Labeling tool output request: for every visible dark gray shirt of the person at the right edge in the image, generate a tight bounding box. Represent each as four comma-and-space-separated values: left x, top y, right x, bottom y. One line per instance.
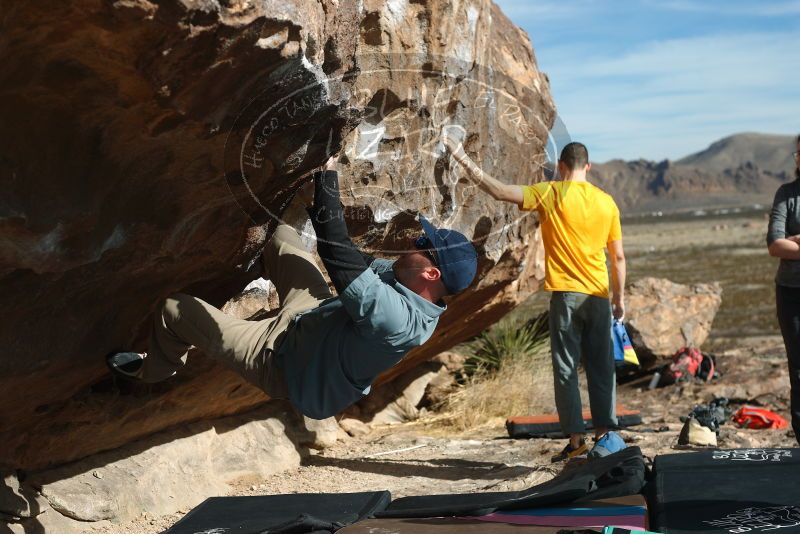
767, 179, 800, 287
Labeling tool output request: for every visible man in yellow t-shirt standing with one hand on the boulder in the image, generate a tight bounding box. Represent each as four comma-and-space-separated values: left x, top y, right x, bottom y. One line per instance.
445, 137, 625, 461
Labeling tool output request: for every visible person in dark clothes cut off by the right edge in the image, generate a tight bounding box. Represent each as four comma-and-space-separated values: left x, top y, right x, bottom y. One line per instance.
767, 135, 800, 443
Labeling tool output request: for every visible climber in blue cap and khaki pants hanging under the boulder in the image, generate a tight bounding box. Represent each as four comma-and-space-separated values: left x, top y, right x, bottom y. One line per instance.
106, 158, 477, 419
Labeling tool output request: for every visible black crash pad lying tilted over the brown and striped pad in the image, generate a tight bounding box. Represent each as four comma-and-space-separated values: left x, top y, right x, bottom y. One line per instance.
375, 447, 645, 518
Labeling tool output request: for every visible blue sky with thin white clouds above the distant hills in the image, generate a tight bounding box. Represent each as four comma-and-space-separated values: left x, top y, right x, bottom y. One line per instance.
495, 0, 800, 161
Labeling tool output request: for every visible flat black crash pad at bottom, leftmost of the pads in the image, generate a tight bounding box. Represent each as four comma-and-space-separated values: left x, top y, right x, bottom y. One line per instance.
163, 491, 391, 534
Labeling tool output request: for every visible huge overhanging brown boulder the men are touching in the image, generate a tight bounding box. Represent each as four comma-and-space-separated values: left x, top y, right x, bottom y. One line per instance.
0, 0, 554, 469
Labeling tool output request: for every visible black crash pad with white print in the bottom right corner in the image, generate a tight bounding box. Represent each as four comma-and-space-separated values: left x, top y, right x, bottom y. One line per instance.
646, 448, 800, 534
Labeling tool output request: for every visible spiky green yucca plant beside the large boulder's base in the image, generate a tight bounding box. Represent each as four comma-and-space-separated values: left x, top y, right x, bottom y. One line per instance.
464, 312, 549, 377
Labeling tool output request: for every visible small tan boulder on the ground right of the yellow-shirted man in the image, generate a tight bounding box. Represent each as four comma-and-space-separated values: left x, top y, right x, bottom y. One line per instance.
625, 278, 722, 357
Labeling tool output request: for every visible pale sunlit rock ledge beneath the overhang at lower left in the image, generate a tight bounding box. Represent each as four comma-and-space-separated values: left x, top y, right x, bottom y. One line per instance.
0, 402, 326, 532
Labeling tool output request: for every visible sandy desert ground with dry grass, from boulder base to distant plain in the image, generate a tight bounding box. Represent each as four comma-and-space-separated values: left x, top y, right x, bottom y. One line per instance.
97, 213, 796, 534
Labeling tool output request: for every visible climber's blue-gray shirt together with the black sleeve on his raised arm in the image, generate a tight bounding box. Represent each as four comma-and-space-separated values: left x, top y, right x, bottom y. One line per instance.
276, 171, 445, 419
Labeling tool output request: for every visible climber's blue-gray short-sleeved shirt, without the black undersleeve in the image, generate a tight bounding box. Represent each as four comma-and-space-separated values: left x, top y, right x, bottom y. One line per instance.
277, 260, 445, 419
